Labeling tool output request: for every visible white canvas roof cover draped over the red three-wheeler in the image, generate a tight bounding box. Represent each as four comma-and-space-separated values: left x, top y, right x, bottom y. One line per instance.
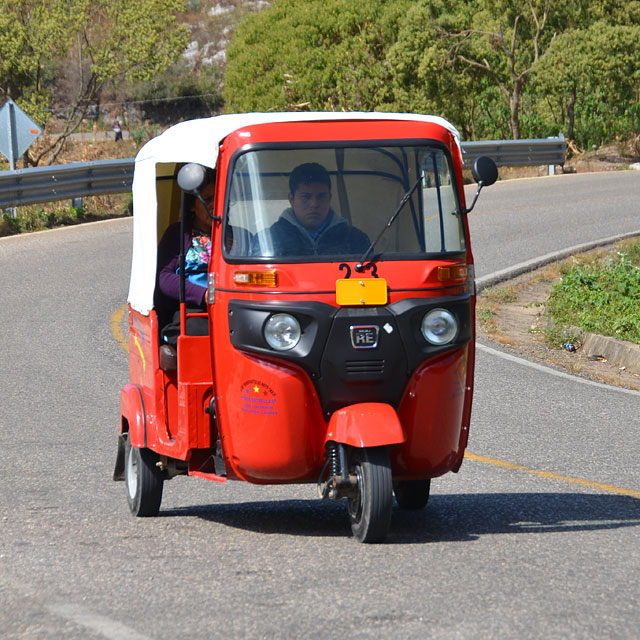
128, 112, 460, 315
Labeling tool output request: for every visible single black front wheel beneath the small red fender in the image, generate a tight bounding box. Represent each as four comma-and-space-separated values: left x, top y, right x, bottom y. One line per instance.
348, 447, 393, 542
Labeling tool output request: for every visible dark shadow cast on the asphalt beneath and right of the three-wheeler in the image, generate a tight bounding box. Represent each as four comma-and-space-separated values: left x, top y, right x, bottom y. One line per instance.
160, 493, 640, 544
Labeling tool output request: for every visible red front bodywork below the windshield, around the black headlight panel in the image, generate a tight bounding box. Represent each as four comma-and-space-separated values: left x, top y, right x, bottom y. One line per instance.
212, 262, 473, 483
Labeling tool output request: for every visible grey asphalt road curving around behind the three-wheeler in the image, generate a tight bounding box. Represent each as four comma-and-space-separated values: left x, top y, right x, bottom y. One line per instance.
0, 172, 640, 640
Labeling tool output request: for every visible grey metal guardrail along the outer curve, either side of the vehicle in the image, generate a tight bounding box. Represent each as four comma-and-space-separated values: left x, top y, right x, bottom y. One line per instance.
0, 135, 566, 208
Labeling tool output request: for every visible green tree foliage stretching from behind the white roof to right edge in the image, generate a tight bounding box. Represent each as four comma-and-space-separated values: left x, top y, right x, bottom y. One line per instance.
224, 0, 640, 145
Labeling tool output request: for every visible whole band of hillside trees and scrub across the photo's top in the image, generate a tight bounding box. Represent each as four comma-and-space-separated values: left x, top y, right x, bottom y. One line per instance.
0, 0, 640, 168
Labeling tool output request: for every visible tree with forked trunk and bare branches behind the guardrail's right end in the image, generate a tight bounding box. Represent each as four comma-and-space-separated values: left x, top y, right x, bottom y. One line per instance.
388, 0, 583, 139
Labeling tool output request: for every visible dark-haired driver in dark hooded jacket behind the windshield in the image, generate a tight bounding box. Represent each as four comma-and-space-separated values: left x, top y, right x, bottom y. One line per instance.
254, 162, 370, 256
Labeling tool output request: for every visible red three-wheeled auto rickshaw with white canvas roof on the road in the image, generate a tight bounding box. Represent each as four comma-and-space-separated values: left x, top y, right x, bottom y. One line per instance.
114, 113, 497, 542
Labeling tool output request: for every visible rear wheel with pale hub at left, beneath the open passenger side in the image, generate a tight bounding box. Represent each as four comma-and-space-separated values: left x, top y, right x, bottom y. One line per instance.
124, 440, 164, 517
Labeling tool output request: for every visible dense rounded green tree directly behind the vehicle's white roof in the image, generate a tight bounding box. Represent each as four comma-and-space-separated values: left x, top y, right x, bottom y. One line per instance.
223, 0, 408, 112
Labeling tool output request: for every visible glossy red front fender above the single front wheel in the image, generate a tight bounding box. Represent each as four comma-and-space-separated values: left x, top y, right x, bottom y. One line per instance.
325, 402, 405, 448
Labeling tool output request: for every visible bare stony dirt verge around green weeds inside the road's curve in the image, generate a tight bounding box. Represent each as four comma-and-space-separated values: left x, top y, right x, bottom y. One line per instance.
477, 246, 640, 391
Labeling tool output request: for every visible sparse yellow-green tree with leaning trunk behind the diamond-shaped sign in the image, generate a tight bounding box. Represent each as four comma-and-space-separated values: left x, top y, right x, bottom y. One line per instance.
0, 0, 188, 165
